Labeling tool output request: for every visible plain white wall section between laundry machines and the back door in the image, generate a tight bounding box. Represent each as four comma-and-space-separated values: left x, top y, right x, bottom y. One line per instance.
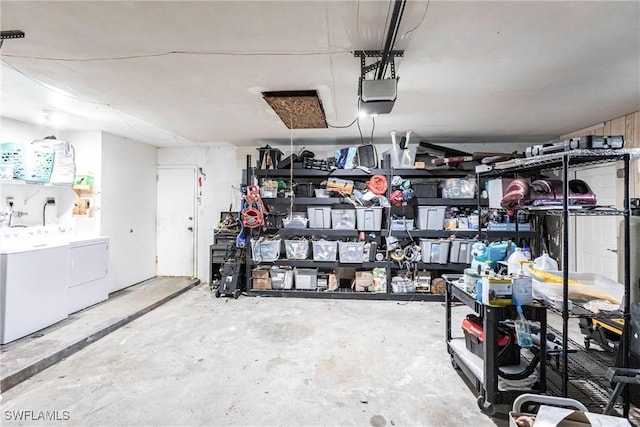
101, 133, 157, 292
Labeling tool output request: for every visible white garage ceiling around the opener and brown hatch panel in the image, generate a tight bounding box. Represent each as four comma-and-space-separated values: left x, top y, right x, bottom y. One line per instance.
0, 0, 640, 146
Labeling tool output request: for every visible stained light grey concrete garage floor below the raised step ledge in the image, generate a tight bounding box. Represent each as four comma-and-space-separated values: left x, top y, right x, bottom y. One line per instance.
0, 285, 506, 427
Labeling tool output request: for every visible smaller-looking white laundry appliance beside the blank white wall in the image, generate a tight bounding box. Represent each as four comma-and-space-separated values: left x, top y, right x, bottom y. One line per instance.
68, 237, 109, 313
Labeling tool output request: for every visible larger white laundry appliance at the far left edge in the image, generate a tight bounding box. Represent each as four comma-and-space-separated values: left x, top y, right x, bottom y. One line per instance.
0, 239, 69, 344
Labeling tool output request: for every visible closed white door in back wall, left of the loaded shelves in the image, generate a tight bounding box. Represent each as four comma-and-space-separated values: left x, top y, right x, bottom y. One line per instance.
156, 167, 196, 277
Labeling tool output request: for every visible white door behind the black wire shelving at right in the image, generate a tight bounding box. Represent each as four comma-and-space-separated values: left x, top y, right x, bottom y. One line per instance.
574, 164, 619, 280
